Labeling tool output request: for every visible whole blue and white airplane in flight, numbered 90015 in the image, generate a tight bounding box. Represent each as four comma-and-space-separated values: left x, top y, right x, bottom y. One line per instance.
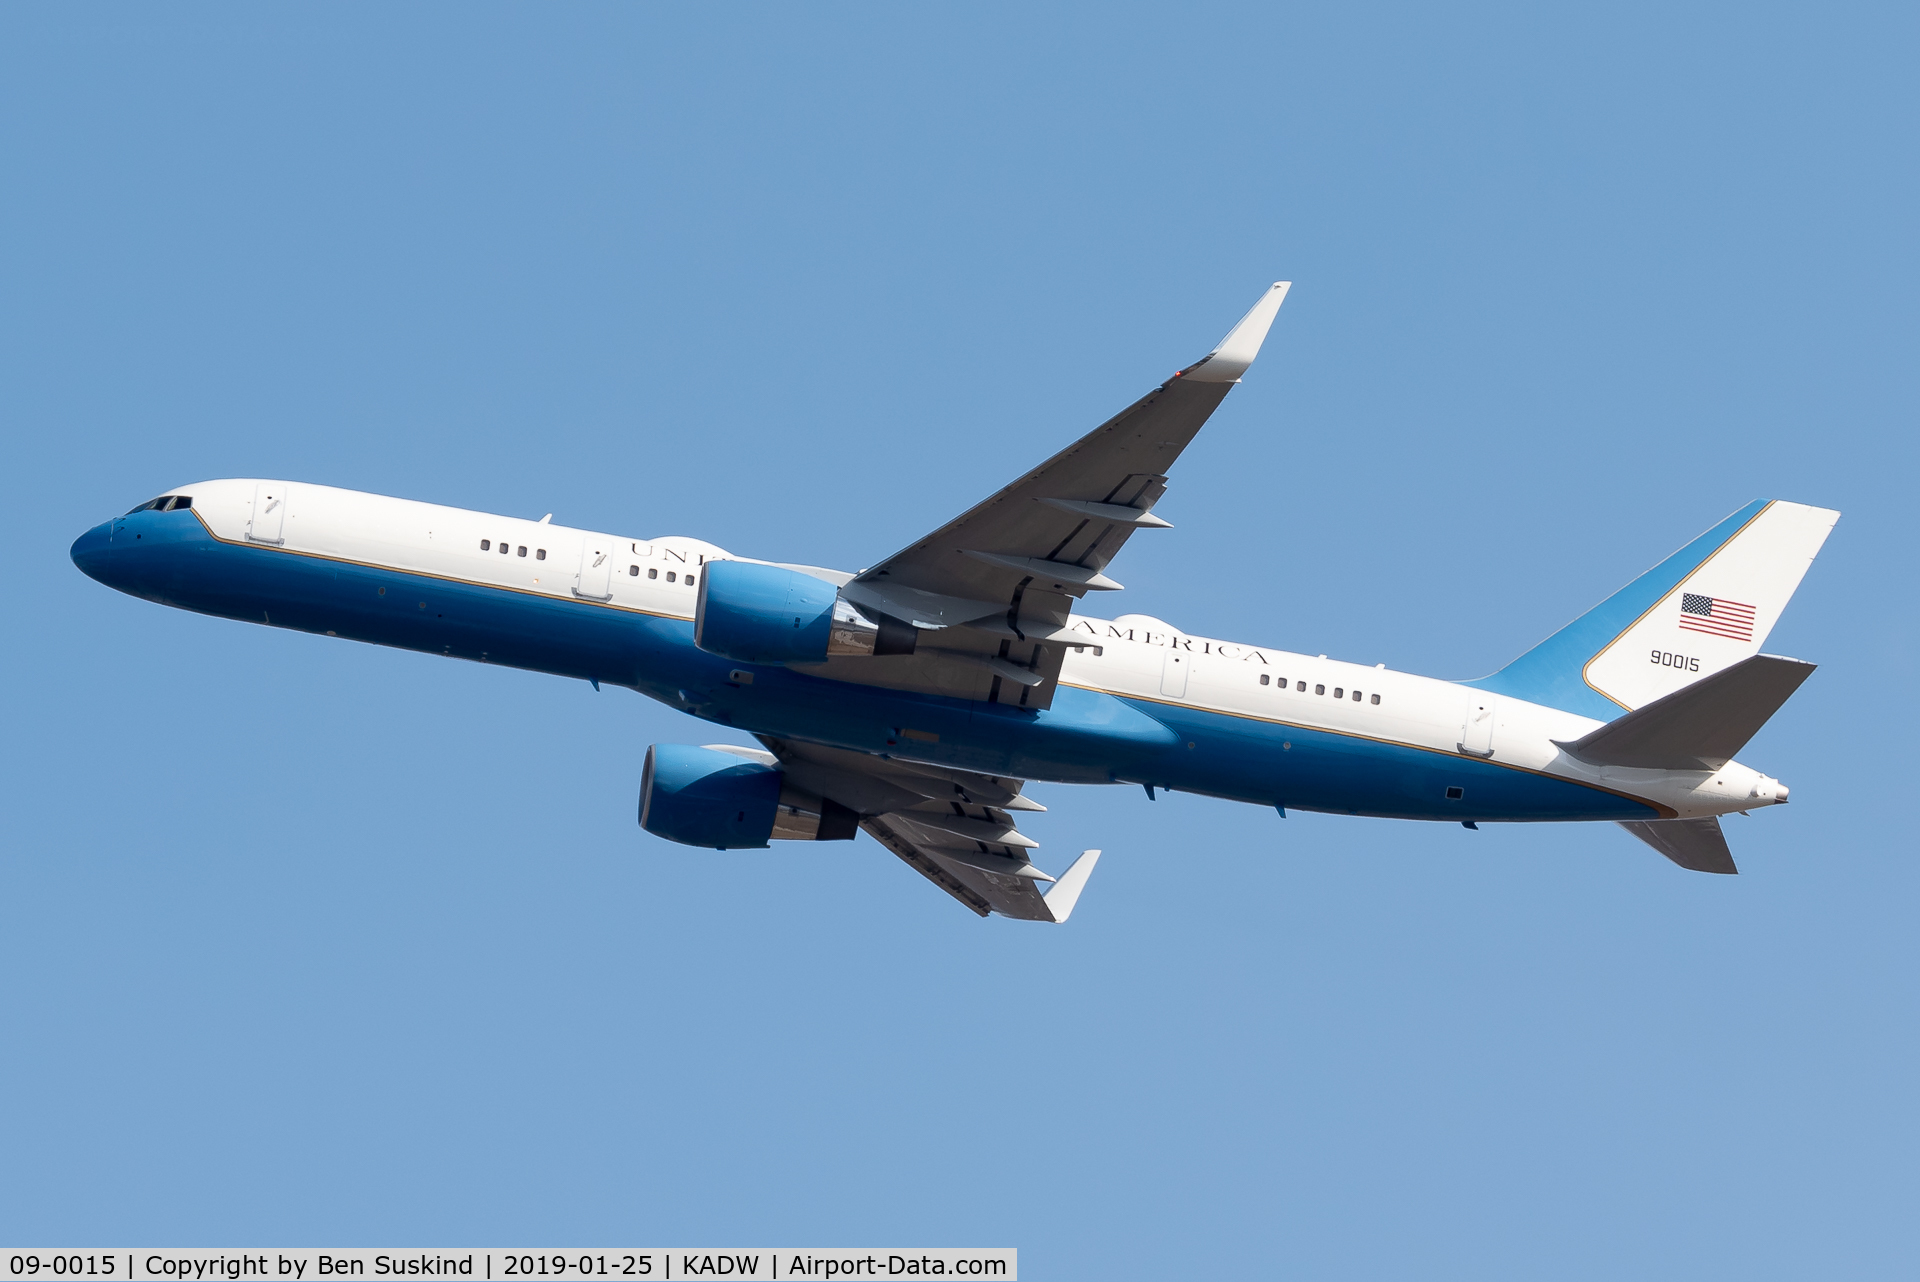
73, 282, 1839, 921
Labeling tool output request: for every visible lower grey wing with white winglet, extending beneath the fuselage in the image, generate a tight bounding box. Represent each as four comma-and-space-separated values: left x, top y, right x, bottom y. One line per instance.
760, 735, 1100, 921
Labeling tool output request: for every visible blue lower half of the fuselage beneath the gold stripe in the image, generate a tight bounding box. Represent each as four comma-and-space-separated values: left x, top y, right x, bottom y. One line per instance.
109, 512, 1655, 819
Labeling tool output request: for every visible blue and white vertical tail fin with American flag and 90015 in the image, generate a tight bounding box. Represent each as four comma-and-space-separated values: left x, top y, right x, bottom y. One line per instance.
1465, 499, 1839, 722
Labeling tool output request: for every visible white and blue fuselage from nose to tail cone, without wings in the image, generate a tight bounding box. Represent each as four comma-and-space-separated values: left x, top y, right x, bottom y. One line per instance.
73, 480, 1797, 821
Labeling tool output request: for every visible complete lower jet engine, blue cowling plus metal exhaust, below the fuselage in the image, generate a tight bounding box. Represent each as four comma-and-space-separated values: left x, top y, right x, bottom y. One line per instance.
639, 740, 860, 850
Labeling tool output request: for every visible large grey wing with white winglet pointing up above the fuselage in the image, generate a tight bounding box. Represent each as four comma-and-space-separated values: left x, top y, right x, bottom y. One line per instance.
798, 280, 1288, 708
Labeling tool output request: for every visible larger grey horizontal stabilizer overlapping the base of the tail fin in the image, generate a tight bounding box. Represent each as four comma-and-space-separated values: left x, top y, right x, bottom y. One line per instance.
1553, 654, 1814, 767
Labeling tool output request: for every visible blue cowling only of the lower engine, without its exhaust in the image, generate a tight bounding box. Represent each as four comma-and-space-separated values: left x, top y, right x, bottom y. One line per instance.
639, 740, 781, 850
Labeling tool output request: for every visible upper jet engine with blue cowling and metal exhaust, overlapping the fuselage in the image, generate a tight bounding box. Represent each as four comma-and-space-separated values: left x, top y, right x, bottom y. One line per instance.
693, 560, 916, 664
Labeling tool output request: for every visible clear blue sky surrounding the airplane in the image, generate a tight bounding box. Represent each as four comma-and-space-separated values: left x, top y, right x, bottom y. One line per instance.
0, 4, 1920, 1278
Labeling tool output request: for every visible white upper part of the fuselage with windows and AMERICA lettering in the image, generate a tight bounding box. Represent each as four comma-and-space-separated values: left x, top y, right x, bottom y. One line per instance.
168, 480, 1784, 818
